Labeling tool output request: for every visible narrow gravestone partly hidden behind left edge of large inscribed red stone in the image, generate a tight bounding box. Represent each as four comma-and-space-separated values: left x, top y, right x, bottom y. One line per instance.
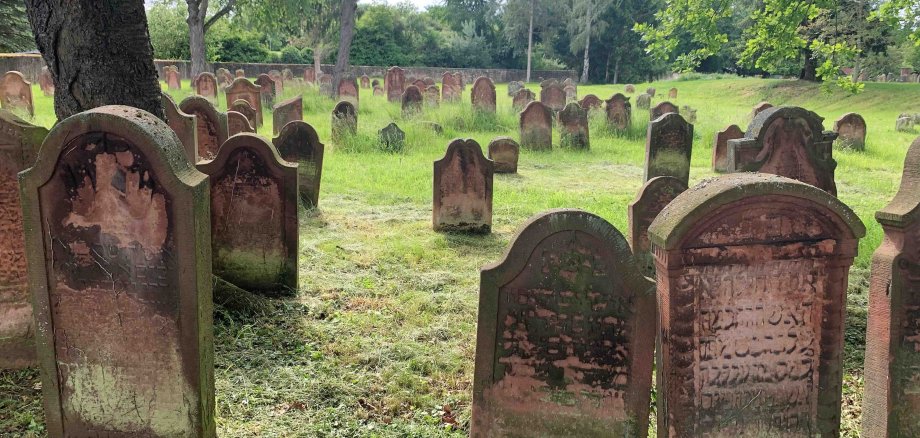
627, 176, 687, 278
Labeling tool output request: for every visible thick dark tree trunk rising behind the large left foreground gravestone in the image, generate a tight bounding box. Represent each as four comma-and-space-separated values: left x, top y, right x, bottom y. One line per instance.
25, 0, 165, 119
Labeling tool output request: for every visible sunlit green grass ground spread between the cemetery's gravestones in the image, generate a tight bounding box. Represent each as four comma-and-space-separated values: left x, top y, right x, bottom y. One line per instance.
0, 73, 920, 437
